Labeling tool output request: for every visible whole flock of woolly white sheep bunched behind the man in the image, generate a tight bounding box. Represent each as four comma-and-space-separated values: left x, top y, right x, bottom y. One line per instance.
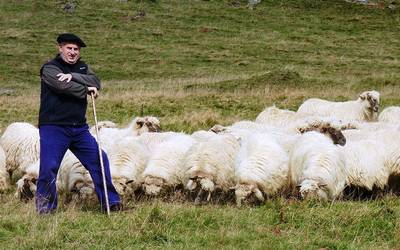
0, 91, 400, 206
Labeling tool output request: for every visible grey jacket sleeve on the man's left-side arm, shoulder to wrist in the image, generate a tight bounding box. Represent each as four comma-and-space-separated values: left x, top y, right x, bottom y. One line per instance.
41, 65, 88, 99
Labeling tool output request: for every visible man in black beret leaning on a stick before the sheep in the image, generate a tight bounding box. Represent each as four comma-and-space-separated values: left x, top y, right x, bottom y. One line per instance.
36, 33, 121, 214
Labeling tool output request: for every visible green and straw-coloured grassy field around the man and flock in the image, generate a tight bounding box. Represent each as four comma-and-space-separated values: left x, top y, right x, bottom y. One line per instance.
0, 0, 400, 249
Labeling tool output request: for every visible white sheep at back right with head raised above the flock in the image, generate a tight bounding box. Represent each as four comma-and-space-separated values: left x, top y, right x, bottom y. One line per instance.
297, 90, 380, 122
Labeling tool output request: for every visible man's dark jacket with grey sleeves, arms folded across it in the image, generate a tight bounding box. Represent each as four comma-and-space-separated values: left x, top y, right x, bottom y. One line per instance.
39, 55, 100, 126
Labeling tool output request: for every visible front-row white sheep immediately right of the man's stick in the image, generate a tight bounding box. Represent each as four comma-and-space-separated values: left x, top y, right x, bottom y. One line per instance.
108, 136, 150, 199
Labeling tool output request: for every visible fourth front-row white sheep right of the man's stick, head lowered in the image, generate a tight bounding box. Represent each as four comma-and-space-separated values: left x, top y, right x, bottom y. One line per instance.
235, 133, 289, 206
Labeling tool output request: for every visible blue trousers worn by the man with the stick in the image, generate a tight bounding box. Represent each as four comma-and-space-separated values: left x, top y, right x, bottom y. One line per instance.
36, 125, 120, 214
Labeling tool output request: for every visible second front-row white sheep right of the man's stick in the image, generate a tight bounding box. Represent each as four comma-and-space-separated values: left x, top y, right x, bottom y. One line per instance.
142, 134, 195, 196
